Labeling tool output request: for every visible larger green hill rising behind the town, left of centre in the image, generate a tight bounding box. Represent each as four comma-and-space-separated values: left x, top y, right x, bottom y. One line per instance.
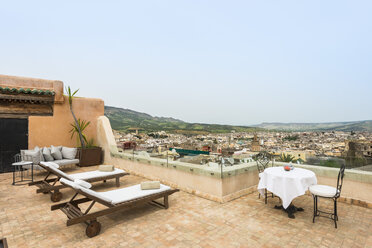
105, 106, 260, 134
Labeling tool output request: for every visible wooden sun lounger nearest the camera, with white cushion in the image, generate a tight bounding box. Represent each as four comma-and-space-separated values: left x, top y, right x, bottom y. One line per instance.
51, 179, 179, 238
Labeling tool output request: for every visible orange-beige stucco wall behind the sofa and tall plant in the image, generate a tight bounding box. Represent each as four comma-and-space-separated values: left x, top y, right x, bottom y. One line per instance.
28, 96, 104, 149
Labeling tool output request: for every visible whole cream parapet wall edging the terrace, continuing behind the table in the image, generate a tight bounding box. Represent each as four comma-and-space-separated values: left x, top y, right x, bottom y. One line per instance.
97, 116, 372, 208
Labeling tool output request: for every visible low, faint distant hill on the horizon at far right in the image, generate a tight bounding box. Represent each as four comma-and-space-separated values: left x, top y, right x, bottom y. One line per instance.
255, 120, 372, 132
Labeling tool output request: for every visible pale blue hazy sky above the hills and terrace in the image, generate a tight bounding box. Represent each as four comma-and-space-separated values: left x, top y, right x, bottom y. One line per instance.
0, 0, 372, 125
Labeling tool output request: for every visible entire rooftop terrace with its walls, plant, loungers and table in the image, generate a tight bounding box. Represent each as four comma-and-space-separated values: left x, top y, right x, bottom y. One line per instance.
0, 75, 372, 247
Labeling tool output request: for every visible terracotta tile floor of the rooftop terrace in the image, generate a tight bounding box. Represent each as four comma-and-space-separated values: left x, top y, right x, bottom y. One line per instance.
0, 168, 372, 248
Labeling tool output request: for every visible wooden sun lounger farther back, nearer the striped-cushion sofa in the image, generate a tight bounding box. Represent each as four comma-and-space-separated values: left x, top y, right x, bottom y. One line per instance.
28, 162, 129, 202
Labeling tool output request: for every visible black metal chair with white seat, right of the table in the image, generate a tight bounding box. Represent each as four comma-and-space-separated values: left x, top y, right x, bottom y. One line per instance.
309, 165, 345, 228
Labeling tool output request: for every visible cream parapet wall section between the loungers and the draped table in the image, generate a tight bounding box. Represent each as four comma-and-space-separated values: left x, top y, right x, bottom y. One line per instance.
97, 116, 258, 202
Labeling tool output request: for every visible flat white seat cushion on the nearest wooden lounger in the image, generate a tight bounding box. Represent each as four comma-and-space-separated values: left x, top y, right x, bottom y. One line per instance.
97, 184, 170, 204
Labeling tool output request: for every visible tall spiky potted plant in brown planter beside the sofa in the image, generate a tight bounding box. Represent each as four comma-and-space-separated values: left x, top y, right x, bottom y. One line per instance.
66, 86, 102, 166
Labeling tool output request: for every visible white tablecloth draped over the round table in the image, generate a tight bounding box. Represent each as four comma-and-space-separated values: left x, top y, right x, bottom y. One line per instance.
257, 167, 317, 208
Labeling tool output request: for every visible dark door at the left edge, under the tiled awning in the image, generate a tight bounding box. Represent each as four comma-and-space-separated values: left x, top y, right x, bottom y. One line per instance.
0, 118, 28, 173
